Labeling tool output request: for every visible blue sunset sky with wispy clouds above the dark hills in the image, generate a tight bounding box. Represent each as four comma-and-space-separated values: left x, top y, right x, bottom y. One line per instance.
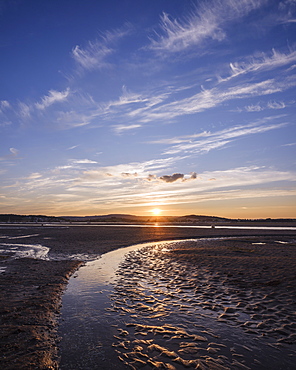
0, 0, 296, 218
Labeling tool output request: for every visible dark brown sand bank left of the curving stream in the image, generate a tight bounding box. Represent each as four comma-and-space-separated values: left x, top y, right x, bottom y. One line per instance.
0, 258, 81, 369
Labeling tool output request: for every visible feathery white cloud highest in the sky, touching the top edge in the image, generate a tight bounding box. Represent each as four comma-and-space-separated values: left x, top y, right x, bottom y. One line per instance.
150, 0, 266, 53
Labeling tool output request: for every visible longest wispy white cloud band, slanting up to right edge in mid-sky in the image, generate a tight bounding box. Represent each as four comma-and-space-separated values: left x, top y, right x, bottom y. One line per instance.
45, 72, 296, 130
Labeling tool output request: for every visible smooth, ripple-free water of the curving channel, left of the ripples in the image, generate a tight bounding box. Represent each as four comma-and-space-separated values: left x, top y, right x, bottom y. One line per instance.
59, 243, 157, 370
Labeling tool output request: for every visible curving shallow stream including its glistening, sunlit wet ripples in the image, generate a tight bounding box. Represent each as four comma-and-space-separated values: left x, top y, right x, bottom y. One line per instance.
59, 240, 294, 370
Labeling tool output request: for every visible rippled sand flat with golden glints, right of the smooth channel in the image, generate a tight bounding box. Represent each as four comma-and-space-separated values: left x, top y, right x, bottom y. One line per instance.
109, 237, 296, 369
